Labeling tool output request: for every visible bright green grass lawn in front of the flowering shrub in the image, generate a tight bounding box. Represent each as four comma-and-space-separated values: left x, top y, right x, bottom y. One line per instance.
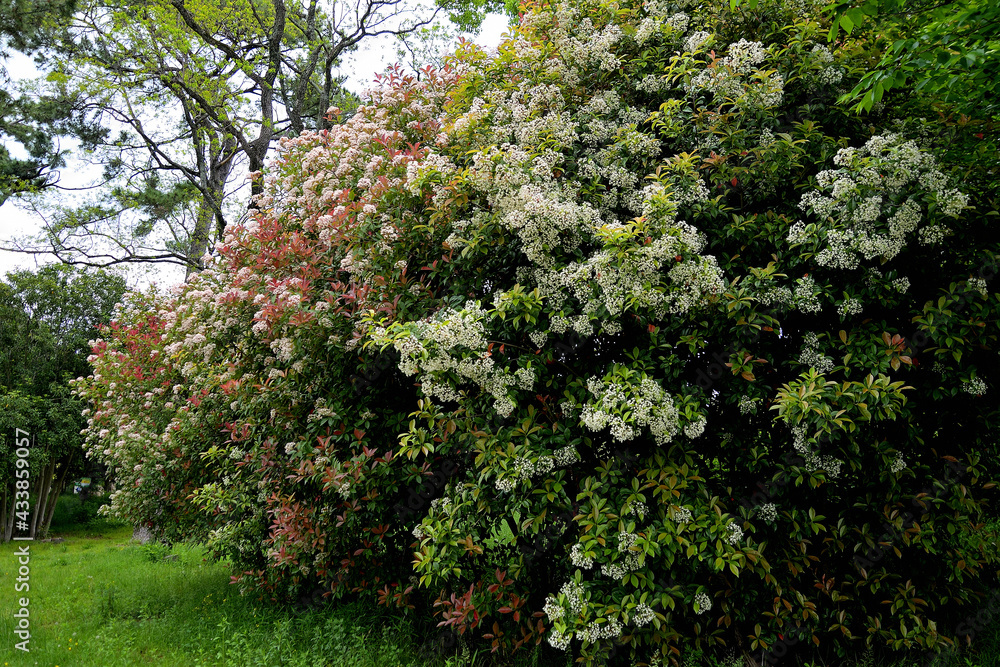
0, 504, 1000, 667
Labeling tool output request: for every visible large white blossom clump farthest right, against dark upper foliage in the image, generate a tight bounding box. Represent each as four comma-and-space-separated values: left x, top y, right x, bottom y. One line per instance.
788, 133, 969, 270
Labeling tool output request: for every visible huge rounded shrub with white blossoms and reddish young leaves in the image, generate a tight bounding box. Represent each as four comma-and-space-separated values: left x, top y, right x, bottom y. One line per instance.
77, 0, 1000, 664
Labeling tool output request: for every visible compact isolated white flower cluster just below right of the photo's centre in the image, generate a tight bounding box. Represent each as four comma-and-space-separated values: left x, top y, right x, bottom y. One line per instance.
580, 375, 679, 445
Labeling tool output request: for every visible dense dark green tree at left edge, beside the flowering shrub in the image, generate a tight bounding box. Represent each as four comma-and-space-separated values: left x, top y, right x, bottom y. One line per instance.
0, 265, 126, 541
